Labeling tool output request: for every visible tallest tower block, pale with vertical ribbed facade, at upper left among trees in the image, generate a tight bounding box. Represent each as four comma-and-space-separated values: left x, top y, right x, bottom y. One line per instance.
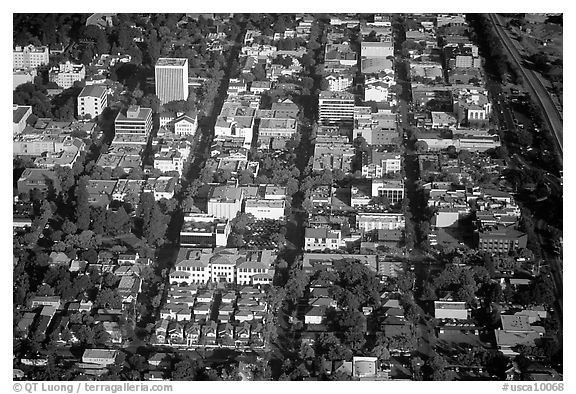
154, 58, 188, 104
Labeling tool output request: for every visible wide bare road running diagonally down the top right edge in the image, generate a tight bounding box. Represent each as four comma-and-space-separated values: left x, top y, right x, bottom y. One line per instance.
489, 14, 563, 154
